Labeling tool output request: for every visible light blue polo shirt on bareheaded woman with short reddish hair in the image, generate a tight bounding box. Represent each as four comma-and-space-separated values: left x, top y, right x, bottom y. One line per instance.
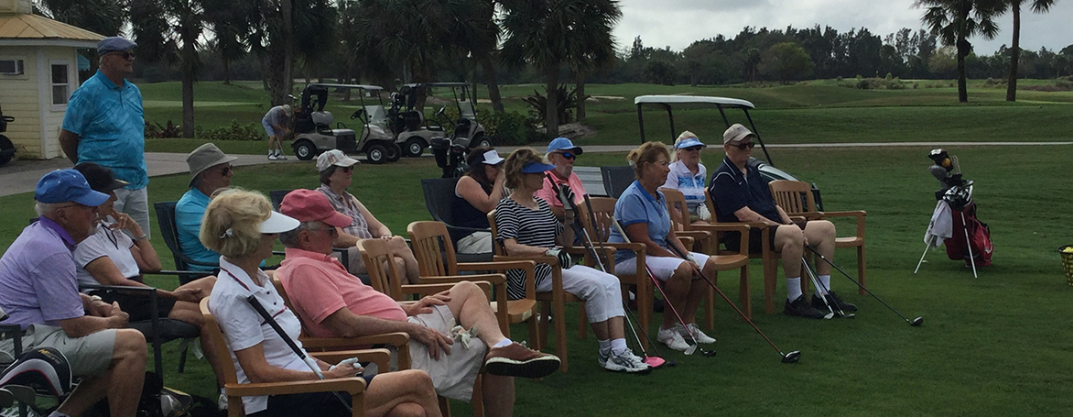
607, 180, 671, 264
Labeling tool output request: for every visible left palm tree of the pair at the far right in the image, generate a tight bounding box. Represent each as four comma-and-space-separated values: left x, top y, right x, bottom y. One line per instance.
914, 0, 1003, 103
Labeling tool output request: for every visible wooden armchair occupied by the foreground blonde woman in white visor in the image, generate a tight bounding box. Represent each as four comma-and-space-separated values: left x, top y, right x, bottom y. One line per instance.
201, 297, 377, 417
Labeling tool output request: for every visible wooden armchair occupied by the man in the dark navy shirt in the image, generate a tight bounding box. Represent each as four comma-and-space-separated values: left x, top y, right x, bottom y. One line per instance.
689, 190, 776, 318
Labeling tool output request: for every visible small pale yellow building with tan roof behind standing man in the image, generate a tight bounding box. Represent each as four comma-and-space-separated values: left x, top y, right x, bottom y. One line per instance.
0, 0, 104, 159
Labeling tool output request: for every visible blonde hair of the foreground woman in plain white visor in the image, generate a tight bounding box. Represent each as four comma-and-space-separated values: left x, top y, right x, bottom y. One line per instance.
199, 189, 271, 258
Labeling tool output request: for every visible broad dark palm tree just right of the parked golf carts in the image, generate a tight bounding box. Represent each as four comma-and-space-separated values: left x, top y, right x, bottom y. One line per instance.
500, 0, 621, 138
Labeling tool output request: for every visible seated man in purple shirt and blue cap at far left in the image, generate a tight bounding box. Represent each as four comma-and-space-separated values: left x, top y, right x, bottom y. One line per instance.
0, 169, 146, 417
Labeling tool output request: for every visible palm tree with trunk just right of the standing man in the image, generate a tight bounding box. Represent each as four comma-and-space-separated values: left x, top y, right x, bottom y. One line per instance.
131, 0, 205, 137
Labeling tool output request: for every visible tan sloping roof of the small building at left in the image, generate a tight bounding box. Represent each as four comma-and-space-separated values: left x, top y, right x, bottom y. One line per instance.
0, 13, 104, 48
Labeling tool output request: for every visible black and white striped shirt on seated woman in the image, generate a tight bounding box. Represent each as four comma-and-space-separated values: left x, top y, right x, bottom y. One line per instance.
496, 197, 562, 300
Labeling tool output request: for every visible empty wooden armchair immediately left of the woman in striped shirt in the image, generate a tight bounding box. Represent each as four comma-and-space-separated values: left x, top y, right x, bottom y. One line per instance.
407, 221, 541, 351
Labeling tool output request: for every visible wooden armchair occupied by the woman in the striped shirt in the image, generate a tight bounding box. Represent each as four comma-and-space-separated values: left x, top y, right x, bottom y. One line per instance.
488, 210, 588, 373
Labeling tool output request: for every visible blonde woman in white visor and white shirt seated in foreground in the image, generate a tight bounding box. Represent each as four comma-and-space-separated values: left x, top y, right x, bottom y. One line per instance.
201, 190, 440, 417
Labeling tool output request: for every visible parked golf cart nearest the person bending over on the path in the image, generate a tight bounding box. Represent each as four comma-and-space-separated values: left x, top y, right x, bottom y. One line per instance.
291, 83, 402, 164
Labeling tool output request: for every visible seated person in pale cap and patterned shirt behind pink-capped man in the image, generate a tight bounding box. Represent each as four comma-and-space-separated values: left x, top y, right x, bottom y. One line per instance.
317, 149, 420, 284
